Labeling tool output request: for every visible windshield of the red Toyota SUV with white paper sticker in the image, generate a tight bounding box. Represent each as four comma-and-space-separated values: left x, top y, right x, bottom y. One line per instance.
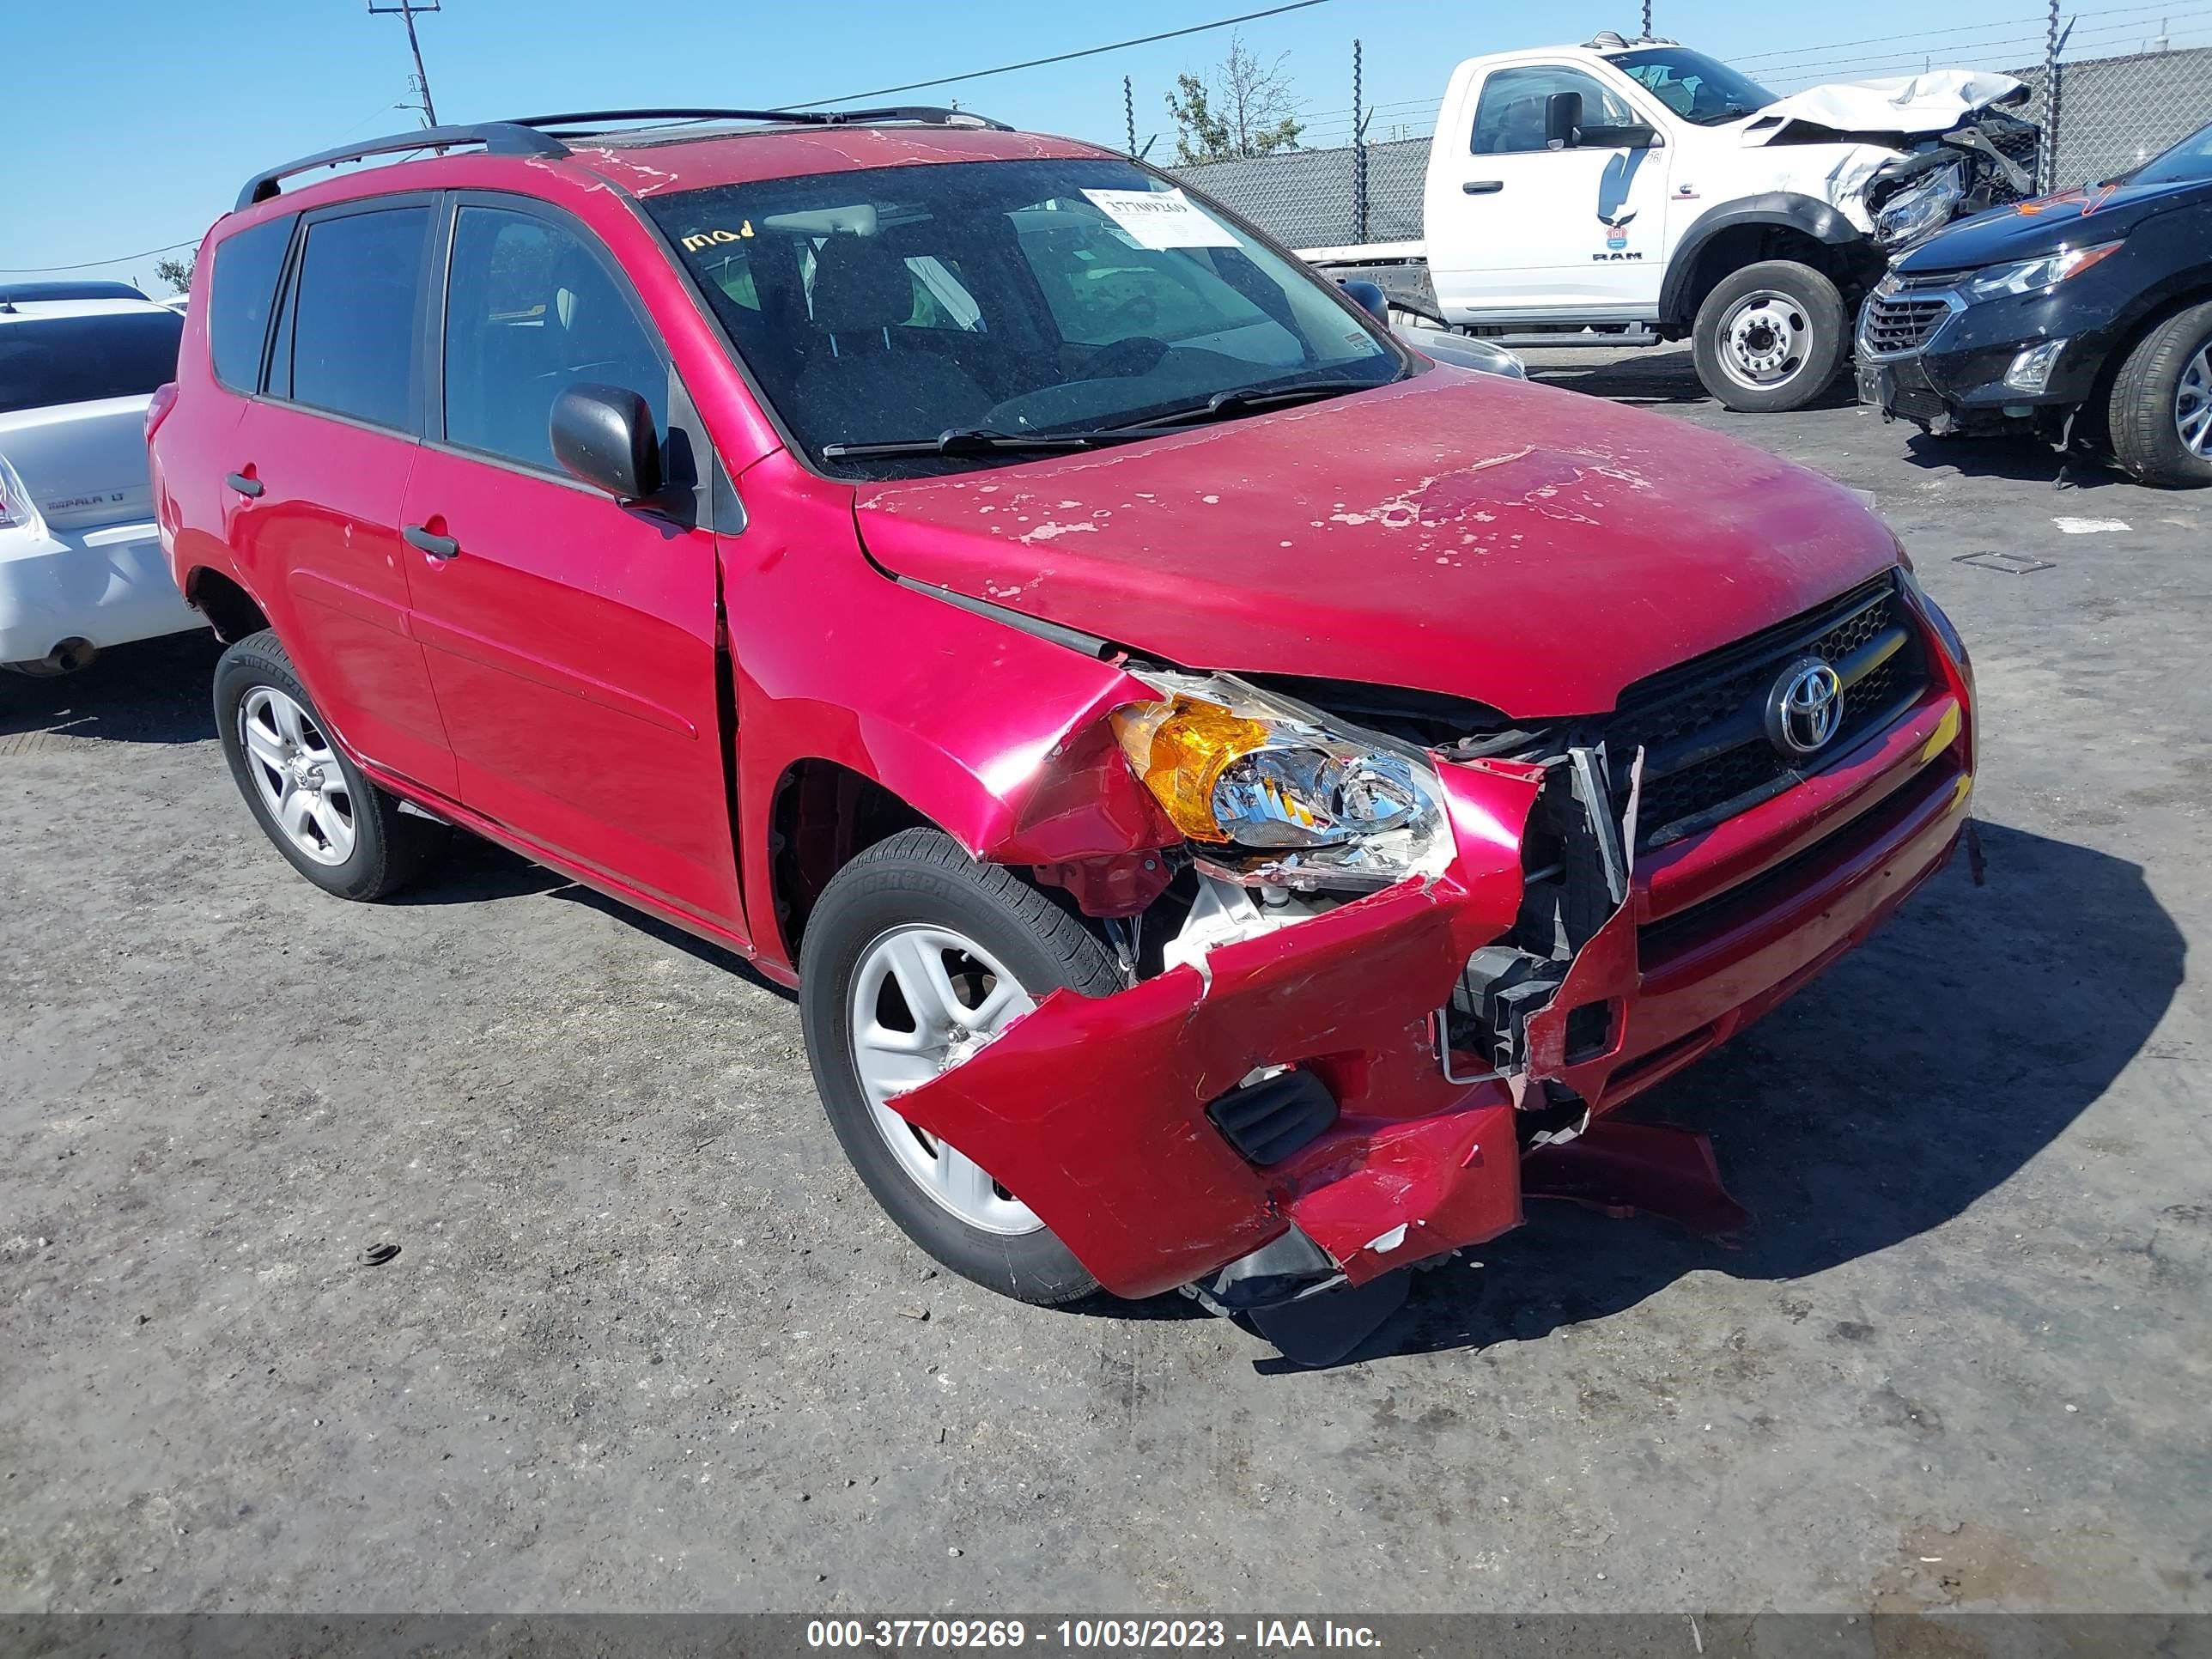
646, 159, 1409, 476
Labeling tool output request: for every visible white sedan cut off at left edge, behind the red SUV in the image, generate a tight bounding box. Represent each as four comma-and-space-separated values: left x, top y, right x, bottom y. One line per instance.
0, 283, 206, 675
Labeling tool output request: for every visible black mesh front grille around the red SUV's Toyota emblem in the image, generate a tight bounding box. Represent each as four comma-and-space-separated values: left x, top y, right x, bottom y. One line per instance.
1604, 575, 1927, 848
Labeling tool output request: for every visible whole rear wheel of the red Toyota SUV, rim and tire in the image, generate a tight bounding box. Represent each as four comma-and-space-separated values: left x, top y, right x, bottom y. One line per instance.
215, 629, 447, 898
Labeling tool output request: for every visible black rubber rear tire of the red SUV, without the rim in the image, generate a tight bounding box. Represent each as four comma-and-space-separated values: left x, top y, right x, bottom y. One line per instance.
215, 629, 452, 900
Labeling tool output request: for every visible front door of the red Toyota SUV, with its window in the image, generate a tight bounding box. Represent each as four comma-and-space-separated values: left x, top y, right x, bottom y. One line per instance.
404, 195, 744, 929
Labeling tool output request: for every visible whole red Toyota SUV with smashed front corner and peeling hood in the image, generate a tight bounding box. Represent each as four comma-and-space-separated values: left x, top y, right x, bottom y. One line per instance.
150, 111, 1973, 1340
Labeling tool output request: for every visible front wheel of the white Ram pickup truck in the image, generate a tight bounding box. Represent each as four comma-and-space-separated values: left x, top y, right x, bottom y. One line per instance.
1692, 258, 1844, 414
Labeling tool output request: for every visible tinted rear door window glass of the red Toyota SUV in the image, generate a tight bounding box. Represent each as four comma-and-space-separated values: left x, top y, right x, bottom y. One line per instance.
289, 208, 429, 431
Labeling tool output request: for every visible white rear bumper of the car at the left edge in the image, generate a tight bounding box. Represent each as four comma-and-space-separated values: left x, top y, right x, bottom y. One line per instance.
0, 522, 206, 661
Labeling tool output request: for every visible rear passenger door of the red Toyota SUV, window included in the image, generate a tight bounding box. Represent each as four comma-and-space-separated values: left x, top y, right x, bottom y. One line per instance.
223, 197, 453, 794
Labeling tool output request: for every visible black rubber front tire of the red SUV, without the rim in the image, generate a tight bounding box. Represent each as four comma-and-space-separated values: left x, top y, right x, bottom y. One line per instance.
799, 830, 1124, 1307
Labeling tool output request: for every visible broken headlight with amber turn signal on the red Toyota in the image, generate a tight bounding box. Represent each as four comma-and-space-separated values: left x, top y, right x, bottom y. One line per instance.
1113, 675, 1449, 887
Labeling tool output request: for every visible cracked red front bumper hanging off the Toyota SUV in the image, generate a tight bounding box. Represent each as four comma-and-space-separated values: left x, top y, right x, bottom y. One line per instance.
896, 654, 1971, 1297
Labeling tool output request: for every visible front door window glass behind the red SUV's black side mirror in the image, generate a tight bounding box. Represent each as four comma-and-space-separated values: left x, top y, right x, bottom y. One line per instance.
445, 206, 668, 471
